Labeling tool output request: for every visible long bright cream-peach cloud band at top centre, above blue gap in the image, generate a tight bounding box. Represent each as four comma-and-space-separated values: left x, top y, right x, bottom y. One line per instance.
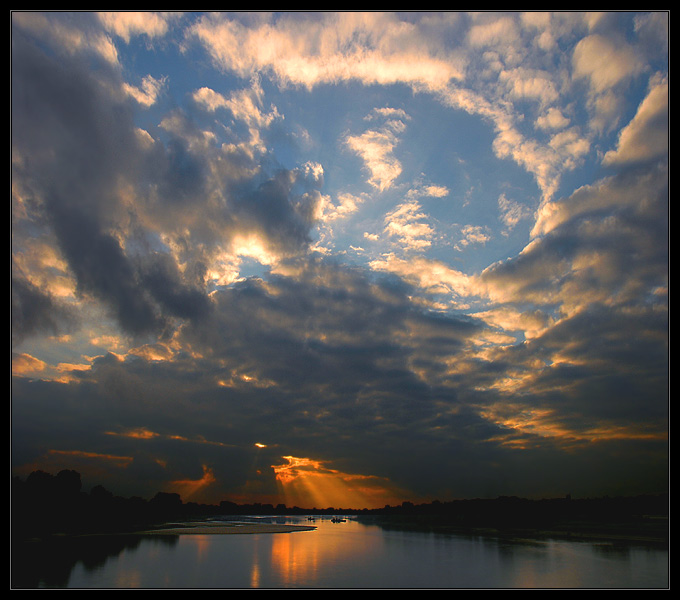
186, 12, 461, 88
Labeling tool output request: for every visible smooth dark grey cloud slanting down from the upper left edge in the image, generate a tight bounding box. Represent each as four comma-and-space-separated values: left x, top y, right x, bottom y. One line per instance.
12, 30, 164, 331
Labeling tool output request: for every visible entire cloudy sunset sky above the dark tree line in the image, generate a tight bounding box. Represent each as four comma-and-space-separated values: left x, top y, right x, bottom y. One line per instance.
11, 11, 669, 508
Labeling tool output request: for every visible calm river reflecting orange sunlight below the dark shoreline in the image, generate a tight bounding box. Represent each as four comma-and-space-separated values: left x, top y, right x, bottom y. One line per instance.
13, 517, 669, 589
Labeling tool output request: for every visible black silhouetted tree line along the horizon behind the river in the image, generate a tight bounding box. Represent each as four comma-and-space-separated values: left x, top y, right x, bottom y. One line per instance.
11, 470, 669, 539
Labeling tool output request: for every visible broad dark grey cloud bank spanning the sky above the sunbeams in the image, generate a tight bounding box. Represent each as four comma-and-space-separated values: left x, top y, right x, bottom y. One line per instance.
14, 244, 665, 498
